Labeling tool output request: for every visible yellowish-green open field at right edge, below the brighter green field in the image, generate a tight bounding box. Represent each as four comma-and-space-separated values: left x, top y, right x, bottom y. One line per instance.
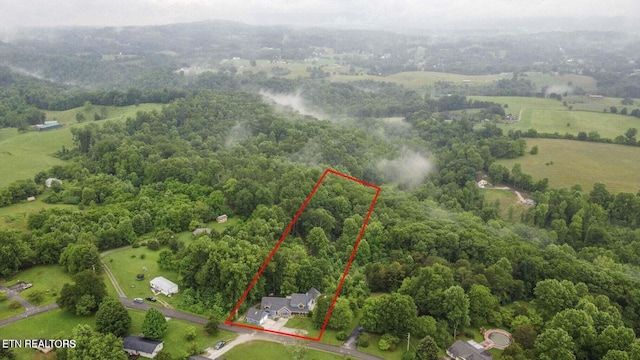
498, 139, 640, 193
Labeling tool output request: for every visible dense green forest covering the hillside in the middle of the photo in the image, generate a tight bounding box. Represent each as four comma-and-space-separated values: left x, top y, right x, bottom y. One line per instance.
0, 83, 640, 359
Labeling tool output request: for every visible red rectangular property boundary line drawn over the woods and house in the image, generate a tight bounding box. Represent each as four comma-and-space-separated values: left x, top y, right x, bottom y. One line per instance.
224, 169, 380, 341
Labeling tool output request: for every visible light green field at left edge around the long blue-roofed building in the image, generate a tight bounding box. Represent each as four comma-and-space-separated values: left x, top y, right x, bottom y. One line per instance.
0, 104, 162, 187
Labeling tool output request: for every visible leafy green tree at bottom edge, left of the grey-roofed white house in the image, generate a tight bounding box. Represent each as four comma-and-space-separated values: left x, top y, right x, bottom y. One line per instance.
67, 325, 128, 360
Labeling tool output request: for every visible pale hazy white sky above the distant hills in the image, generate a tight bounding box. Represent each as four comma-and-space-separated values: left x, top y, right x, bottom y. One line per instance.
0, 0, 640, 28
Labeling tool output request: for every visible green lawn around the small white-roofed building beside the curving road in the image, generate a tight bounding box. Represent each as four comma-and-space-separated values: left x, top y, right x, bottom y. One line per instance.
103, 246, 182, 308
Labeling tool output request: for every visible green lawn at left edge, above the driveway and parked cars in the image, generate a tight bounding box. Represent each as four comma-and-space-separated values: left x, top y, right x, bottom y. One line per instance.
3, 265, 72, 305
